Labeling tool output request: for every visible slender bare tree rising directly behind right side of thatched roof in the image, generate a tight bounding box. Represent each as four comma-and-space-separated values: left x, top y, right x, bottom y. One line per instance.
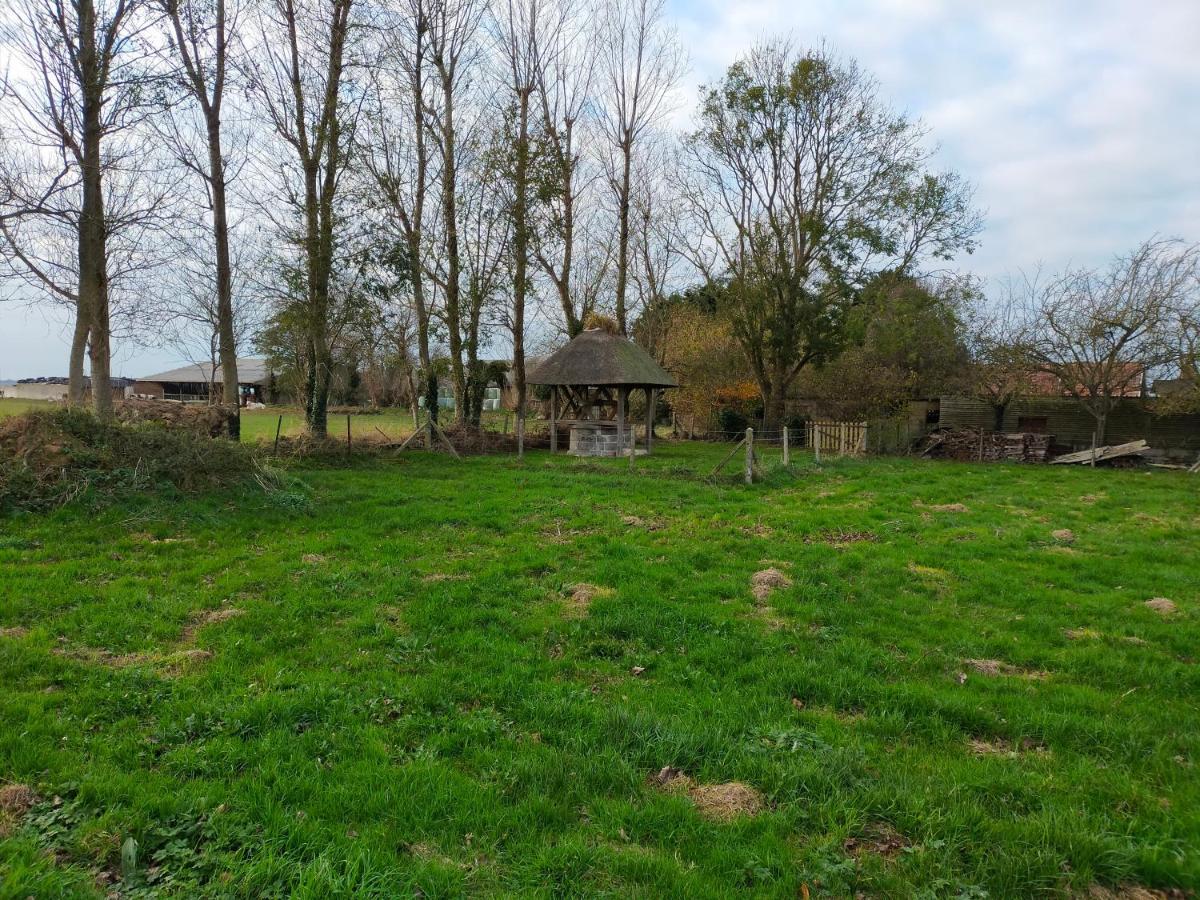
596, 0, 685, 335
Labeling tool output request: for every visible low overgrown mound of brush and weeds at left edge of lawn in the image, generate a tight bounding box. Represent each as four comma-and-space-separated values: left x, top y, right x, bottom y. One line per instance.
0, 408, 259, 511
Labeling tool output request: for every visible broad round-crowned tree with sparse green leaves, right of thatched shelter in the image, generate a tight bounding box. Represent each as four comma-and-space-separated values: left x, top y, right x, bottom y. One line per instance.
685, 42, 979, 432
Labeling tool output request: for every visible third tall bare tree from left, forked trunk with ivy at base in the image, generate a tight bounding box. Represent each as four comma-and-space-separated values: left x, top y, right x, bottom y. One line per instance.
247, 0, 356, 438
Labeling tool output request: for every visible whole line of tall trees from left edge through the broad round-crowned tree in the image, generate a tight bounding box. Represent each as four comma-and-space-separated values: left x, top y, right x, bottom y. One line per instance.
0, 0, 1190, 436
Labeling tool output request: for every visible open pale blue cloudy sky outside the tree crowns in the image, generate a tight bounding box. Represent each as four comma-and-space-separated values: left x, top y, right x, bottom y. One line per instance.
0, 0, 1200, 379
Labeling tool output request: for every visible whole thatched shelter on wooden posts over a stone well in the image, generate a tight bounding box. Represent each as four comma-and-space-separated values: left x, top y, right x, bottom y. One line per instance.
527, 328, 679, 456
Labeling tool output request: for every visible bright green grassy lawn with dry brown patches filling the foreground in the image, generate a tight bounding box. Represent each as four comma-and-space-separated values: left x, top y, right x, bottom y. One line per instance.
0, 448, 1200, 898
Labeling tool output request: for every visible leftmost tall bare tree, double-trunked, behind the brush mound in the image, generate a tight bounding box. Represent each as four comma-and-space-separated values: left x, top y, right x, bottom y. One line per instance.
0, 0, 155, 416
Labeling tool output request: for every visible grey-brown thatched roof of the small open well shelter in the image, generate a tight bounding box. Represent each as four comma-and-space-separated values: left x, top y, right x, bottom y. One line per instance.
526, 328, 679, 388
